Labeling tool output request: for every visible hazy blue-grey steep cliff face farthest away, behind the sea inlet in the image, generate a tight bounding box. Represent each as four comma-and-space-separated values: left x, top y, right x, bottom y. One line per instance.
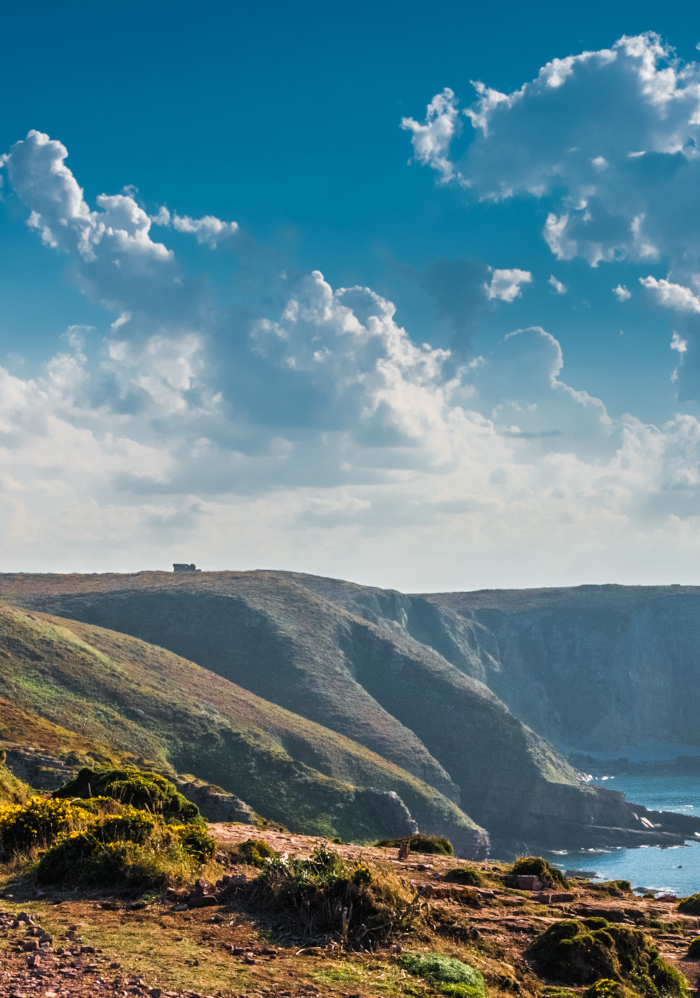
427, 586, 700, 752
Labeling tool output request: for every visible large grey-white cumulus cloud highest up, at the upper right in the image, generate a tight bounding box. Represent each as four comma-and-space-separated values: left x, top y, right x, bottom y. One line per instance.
404, 32, 700, 267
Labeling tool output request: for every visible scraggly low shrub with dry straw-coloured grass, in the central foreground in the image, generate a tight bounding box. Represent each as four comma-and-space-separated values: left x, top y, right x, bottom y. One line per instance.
249, 846, 420, 946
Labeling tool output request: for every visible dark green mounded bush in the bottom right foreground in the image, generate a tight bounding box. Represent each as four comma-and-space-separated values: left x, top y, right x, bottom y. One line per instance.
525, 918, 687, 998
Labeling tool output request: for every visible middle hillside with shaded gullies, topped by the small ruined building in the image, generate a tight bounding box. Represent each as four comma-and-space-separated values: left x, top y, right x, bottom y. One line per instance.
0, 572, 636, 842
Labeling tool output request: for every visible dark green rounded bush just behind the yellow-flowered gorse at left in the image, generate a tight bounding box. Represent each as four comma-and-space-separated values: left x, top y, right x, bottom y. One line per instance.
53, 767, 205, 825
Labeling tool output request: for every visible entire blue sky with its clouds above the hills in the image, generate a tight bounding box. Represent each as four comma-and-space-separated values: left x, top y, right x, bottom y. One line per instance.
0, 2, 700, 590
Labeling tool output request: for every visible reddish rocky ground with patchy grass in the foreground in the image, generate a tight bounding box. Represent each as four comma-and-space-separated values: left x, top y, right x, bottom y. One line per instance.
0, 825, 700, 998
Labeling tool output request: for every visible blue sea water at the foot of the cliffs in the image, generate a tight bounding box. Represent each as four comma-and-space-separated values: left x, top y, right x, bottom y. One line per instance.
548, 774, 700, 897
